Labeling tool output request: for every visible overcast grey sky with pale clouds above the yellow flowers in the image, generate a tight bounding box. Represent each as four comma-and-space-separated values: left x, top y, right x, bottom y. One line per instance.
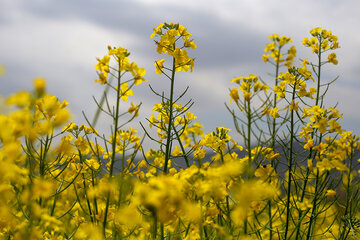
0, 0, 360, 146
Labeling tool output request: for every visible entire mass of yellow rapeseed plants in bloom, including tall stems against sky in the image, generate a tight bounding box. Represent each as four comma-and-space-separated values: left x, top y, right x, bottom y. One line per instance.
0, 23, 360, 240
